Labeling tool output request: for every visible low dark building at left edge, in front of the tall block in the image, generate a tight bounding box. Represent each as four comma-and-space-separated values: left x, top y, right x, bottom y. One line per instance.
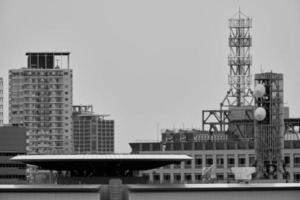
0, 126, 26, 184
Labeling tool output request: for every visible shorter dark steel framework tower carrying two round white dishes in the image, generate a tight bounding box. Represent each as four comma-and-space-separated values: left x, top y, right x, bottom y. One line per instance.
254, 72, 285, 179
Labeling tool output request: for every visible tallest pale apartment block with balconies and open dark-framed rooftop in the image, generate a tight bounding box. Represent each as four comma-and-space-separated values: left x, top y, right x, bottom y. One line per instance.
9, 52, 73, 154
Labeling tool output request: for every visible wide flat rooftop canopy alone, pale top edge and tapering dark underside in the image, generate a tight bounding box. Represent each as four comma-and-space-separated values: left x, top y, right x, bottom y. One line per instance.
11, 154, 192, 174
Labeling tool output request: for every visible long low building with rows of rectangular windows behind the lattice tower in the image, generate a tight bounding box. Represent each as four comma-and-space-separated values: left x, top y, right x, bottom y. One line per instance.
130, 130, 300, 184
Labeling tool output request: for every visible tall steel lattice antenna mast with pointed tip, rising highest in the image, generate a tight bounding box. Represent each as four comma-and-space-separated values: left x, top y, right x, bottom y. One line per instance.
220, 10, 253, 110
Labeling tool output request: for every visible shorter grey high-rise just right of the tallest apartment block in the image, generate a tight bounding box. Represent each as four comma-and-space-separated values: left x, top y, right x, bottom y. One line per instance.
73, 105, 114, 153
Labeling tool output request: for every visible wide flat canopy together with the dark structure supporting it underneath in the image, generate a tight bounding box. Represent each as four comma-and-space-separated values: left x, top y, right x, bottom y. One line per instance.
11, 154, 191, 184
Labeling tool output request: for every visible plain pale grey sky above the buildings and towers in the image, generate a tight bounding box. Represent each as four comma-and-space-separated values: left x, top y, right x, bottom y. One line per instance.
0, 0, 300, 153
